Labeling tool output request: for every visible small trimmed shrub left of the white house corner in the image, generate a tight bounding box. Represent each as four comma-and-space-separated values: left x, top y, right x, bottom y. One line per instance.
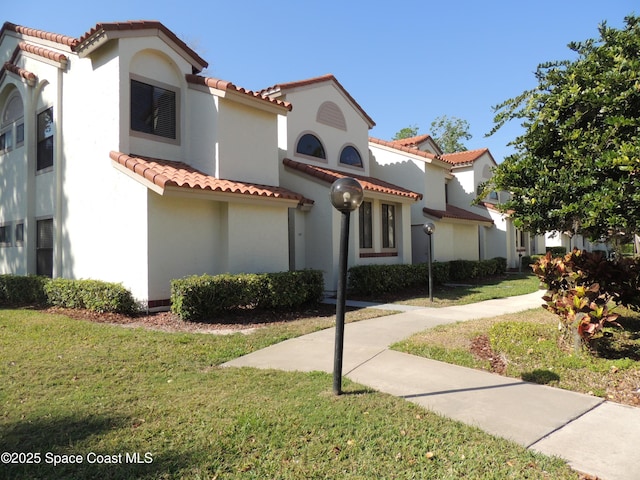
44, 278, 138, 315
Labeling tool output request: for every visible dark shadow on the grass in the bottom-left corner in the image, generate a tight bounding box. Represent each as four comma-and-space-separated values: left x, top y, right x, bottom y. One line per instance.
0, 416, 200, 480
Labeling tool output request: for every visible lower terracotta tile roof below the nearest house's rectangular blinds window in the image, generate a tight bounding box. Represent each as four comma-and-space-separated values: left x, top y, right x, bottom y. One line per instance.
109, 151, 313, 204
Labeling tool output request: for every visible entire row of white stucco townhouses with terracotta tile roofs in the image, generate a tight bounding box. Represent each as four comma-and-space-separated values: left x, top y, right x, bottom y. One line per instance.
0, 21, 536, 309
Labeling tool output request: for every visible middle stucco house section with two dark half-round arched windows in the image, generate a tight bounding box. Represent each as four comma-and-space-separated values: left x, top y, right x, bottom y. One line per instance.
261, 74, 422, 290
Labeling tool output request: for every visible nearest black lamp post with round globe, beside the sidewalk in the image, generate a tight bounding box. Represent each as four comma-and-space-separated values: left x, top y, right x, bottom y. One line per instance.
330, 177, 364, 395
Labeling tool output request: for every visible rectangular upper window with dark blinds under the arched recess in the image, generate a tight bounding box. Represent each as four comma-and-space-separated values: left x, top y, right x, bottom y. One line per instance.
131, 79, 177, 140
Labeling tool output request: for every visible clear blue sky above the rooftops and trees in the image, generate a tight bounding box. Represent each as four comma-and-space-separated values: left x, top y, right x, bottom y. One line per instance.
0, 0, 640, 162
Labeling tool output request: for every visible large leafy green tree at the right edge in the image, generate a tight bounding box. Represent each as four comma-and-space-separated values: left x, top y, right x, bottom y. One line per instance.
479, 16, 640, 239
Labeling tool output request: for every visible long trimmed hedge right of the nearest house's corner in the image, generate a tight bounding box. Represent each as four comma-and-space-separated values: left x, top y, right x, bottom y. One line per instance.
171, 270, 324, 320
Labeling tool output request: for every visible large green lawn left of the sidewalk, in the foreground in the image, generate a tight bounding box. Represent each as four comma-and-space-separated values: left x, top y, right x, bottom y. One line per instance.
0, 310, 578, 479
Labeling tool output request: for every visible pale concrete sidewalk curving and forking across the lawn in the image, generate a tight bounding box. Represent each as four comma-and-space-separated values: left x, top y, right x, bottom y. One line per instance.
223, 292, 640, 480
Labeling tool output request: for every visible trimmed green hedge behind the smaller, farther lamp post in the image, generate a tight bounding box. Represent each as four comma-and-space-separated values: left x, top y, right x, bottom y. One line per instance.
349, 257, 507, 296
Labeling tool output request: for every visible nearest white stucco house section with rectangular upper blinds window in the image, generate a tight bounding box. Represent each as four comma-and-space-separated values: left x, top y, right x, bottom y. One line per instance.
0, 21, 313, 308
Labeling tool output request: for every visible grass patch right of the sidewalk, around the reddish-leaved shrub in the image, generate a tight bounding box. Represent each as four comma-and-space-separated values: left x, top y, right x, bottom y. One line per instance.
392, 308, 640, 405
